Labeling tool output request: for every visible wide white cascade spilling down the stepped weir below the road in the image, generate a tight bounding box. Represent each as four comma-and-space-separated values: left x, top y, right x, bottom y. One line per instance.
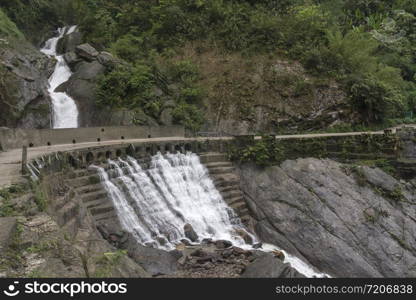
93, 152, 325, 277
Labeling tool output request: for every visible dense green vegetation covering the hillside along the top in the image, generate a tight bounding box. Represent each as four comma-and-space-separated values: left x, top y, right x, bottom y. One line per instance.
0, 0, 416, 130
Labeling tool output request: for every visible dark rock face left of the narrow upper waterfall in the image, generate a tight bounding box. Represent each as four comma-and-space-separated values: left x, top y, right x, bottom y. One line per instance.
0, 39, 55, 128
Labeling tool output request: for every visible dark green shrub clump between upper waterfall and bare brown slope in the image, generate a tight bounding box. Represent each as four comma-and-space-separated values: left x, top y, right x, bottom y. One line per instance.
97, 56, 204, 132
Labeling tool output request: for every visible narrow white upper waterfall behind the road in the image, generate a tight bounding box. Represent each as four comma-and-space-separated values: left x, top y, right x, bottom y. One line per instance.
40, 26, 78, 128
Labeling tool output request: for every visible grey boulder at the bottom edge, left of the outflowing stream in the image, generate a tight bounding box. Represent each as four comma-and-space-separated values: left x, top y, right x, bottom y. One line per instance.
241, 253, 305, 278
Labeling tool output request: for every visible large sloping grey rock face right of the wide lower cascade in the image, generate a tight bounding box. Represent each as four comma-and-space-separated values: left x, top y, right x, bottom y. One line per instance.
240, 158, 416, 277
